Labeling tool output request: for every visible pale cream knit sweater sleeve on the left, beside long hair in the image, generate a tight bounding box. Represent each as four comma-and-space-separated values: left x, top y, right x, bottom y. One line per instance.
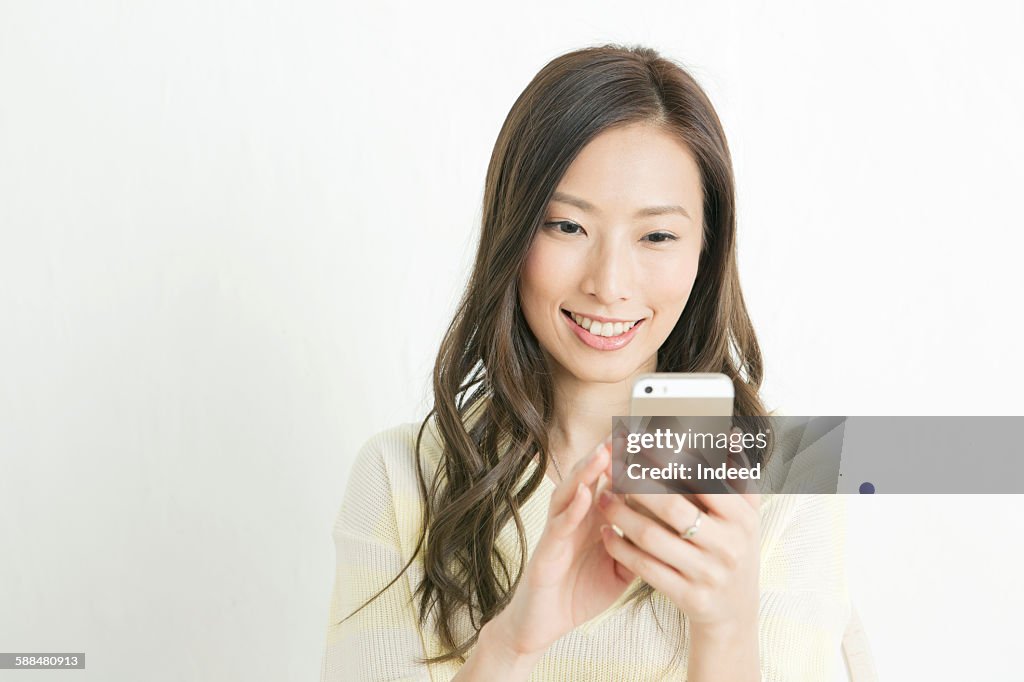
321, 429, 431, 682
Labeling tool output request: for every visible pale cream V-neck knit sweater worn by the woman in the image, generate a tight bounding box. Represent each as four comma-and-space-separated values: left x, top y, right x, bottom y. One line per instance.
321, 423, 851, 682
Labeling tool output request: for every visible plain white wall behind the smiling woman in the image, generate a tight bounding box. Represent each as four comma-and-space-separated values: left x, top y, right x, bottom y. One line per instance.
0, 0, 1024, 681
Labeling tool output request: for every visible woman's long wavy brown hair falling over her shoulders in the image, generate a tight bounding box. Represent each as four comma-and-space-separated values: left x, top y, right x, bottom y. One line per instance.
349, 45, 767, 660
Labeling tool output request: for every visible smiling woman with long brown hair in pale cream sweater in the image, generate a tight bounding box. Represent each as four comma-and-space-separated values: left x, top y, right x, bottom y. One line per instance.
323, 46, 850, 682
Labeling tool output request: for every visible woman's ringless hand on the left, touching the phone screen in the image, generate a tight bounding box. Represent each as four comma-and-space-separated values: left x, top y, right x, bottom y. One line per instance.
481, 436, 634, 656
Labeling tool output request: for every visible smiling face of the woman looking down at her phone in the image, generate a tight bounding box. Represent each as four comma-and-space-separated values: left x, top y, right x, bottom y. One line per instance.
519, 123, 703, 382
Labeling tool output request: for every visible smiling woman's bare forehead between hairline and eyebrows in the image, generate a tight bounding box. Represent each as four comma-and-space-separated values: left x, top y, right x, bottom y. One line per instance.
557, 123, 702, 215
